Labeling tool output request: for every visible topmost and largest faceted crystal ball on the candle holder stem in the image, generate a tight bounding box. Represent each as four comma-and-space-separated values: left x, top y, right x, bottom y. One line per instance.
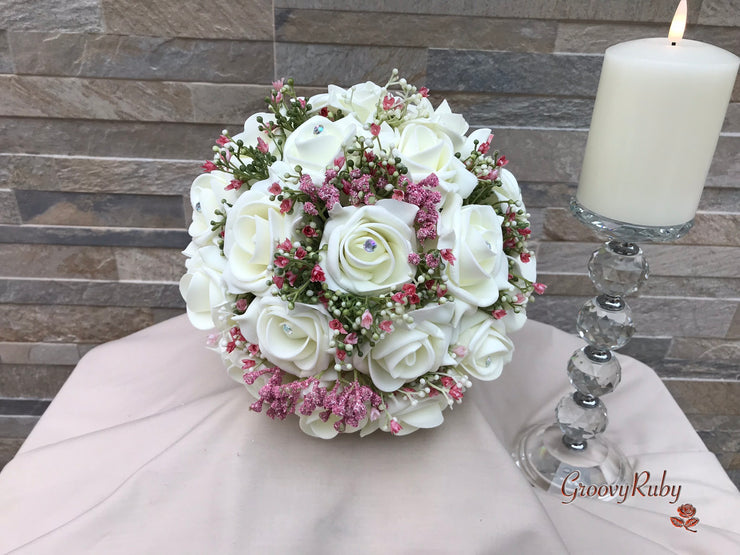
588, 241, 648, 297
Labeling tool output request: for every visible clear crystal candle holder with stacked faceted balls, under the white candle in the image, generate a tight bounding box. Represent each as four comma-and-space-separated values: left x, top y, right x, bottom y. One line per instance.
512, 198, 693, 499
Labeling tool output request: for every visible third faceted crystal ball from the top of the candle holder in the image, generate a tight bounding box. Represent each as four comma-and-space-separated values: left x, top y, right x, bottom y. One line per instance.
568, 345, 622, 397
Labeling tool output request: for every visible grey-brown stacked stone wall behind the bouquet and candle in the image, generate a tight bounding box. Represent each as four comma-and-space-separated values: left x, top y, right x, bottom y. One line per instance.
0, 0, 740, 477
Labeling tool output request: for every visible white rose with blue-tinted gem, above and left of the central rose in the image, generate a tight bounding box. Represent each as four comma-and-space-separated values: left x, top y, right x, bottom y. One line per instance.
283, 116, 362, 175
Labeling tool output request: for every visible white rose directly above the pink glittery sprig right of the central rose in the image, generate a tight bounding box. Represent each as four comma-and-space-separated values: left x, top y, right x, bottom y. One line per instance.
398, 124, 478, 198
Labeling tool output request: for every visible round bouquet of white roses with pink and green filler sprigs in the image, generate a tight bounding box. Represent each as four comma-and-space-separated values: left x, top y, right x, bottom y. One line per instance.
180, 71, 544, 438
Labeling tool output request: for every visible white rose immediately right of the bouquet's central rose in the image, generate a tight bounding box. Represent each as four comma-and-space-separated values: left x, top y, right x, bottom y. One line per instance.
437, 196, 509, 306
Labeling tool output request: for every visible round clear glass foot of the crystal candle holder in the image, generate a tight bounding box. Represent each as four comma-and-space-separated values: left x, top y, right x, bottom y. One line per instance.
512, 423, 632, 501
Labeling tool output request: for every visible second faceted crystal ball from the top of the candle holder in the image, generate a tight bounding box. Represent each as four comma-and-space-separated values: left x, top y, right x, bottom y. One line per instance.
576, 295, 635, 350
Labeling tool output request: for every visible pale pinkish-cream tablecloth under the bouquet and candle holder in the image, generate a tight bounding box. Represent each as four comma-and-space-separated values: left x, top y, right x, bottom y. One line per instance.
0, 317, 740, 554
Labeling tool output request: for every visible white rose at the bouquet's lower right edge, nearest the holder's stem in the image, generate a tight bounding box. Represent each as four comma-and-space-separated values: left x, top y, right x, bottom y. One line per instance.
455, 310, 514, 381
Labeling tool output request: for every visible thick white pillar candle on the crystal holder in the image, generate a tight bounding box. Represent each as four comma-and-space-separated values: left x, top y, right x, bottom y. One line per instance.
576, 7, 740, 226
